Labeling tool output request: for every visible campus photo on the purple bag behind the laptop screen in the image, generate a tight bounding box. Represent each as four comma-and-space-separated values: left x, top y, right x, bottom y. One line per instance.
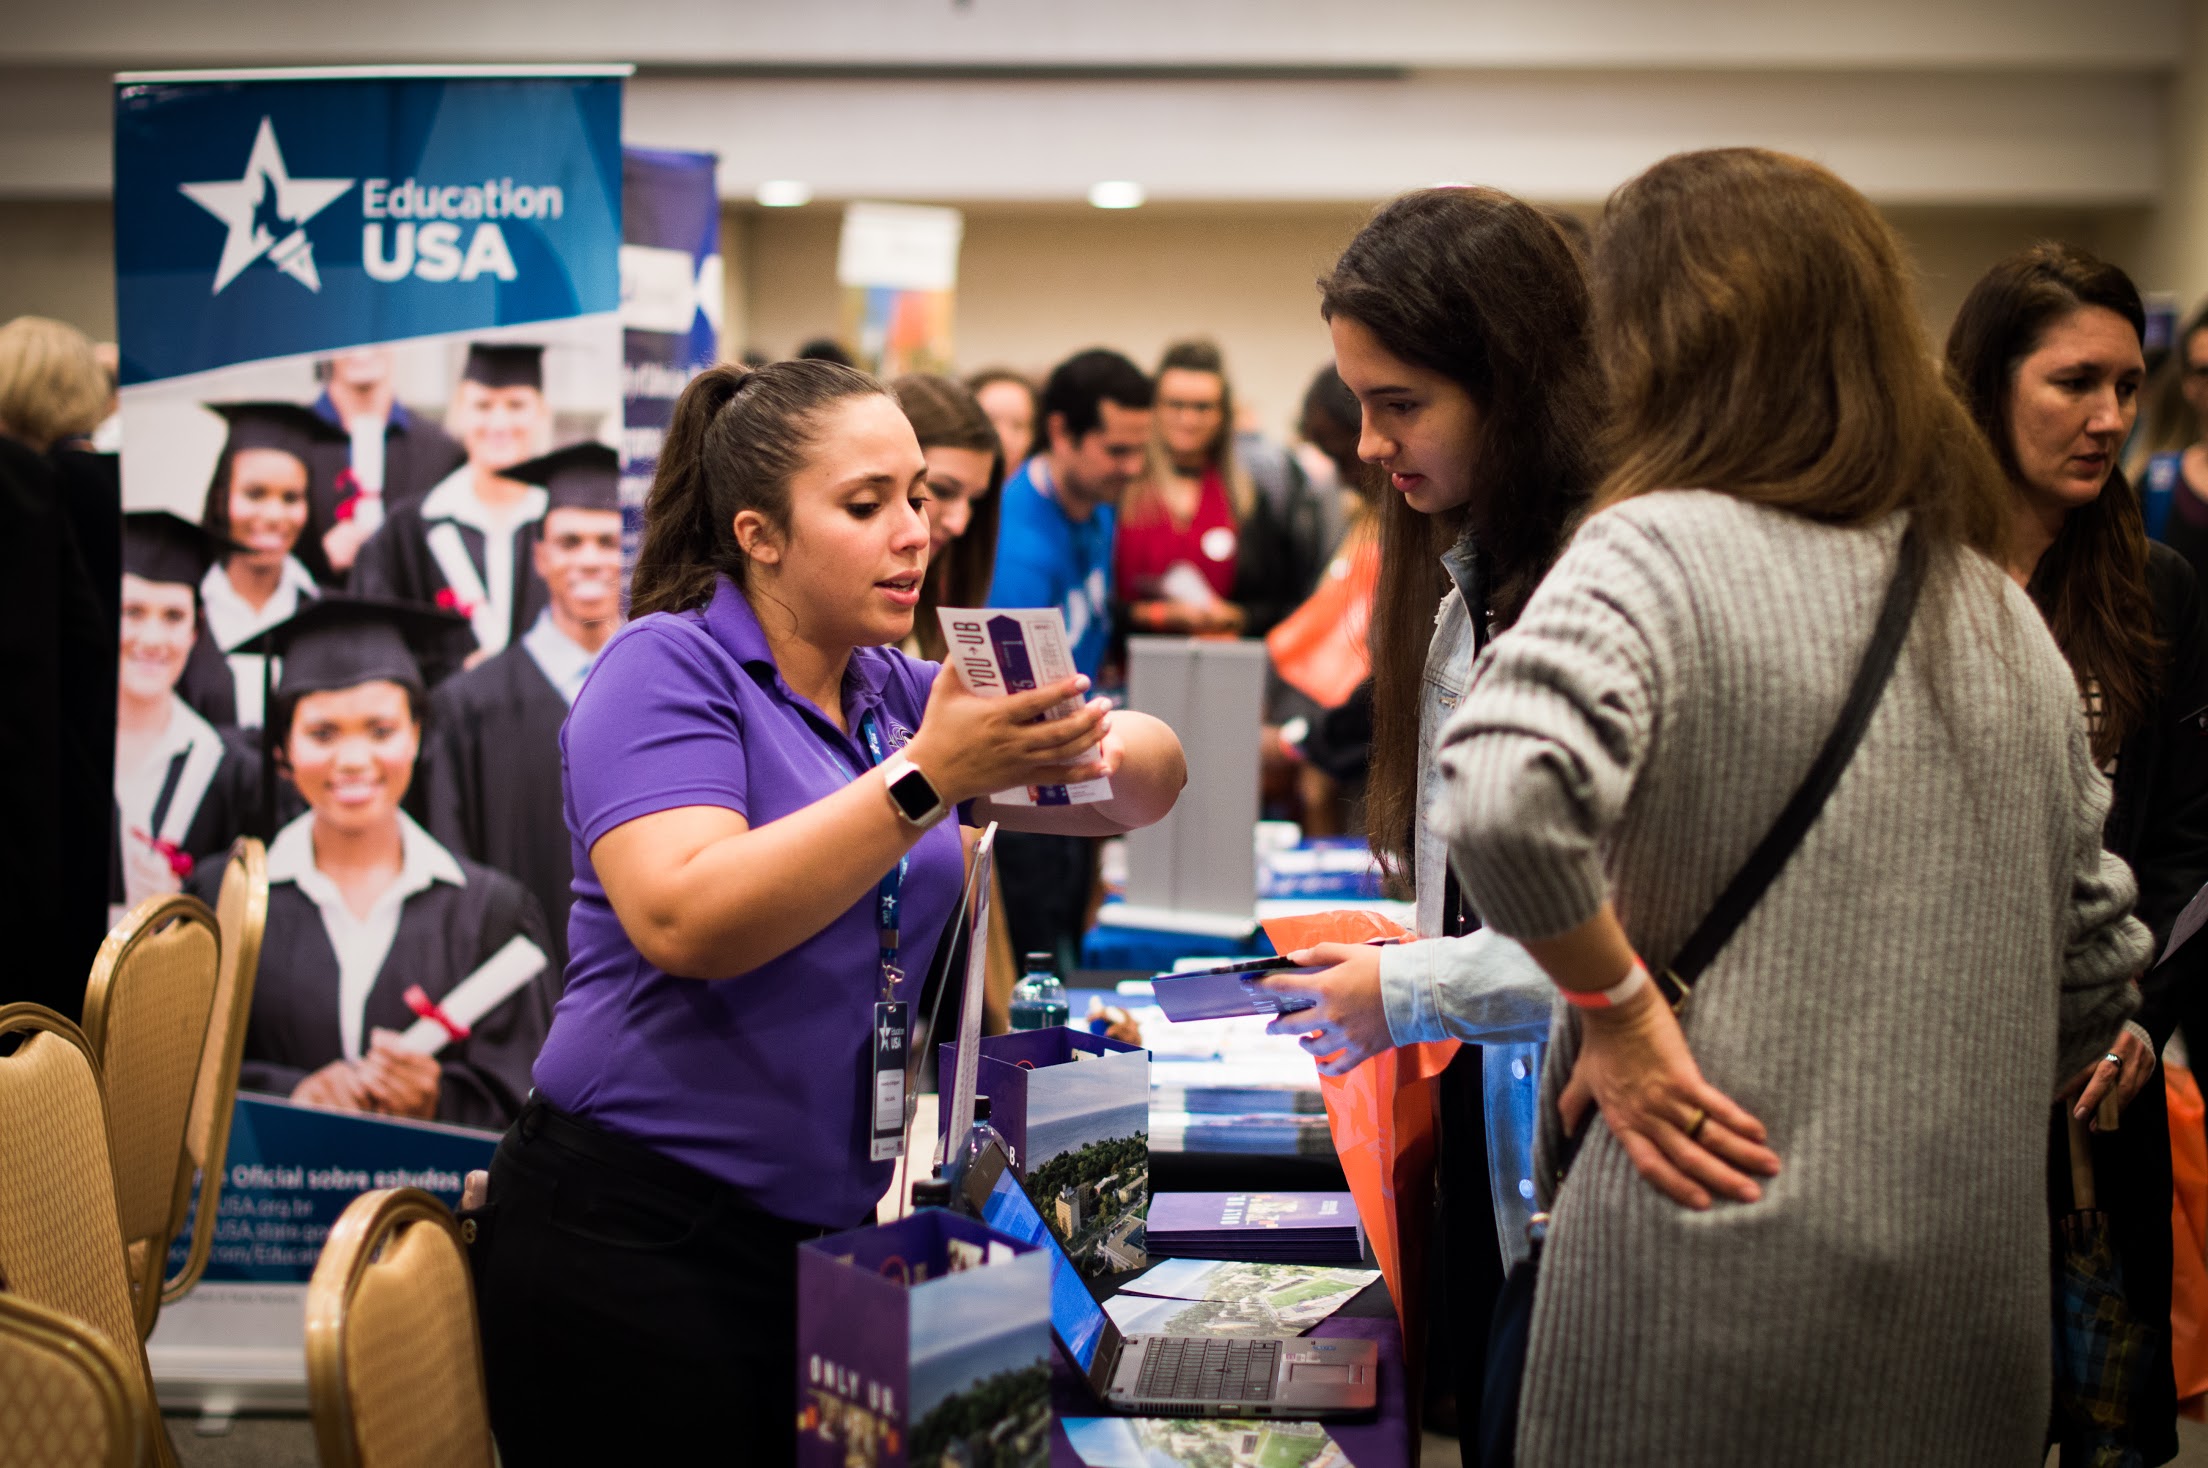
1022, 1051, 1150, 1278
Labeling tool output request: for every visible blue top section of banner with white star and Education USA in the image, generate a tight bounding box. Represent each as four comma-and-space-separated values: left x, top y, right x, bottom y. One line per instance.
115, 68, 620, 386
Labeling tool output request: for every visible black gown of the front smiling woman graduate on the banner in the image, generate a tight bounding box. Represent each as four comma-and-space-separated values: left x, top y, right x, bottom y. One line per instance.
190, 857, 559, 1130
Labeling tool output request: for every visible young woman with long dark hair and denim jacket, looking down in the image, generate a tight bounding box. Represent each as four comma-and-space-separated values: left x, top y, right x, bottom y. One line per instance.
1245, 188, 1601, 1461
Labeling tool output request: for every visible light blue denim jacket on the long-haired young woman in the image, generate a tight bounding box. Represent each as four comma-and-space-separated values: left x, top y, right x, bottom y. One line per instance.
1380, 532, 1557, 1269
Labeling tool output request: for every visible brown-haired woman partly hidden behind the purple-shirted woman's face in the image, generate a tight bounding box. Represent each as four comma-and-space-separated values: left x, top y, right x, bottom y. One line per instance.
890, 373, 1005, 662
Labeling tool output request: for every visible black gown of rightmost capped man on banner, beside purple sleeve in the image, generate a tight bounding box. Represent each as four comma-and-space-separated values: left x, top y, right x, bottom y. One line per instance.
424, 642, 574, 971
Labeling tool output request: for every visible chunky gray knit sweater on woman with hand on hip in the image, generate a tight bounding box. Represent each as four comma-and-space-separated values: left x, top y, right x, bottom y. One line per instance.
1433, 492, 2148, 1468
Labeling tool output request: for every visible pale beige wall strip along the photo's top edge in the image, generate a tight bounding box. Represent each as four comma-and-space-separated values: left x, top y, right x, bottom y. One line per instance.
7, 0, 2184, 71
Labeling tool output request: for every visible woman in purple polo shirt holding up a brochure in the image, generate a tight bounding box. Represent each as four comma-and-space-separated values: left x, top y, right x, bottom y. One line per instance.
475, 362, 1186, 1466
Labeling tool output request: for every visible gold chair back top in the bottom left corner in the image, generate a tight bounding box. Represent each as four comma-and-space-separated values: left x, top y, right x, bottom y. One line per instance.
0, 1291, 146, 1468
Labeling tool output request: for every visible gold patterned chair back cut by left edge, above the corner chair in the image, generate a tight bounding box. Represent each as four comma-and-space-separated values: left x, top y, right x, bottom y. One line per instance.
0, 1004, 174, 1464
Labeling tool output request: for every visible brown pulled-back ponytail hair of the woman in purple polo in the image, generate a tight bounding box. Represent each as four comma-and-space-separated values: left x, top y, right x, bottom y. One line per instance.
629, 362, 883, 616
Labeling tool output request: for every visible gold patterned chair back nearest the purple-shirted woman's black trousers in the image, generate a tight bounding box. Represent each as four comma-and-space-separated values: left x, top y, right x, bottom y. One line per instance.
307, 1188, 495, 1468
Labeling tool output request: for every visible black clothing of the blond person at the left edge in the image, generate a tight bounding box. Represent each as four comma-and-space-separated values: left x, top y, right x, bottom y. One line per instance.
0, 435, 109, 1018
